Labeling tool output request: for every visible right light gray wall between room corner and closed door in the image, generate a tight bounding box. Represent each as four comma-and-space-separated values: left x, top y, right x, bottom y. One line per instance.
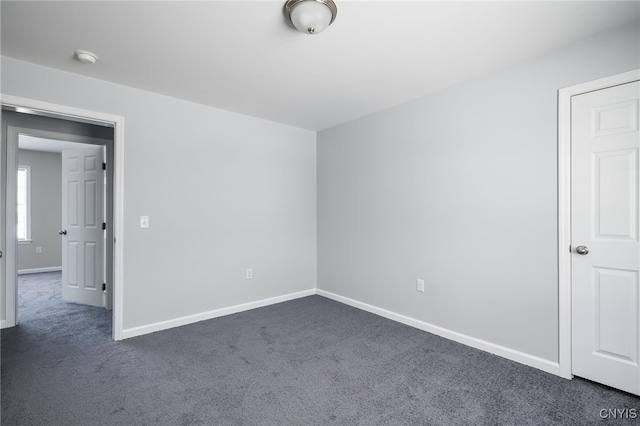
318, 23, 640, 361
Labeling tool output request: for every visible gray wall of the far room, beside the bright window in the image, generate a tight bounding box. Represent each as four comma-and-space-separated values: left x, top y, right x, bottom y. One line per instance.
18, 150, 62, 270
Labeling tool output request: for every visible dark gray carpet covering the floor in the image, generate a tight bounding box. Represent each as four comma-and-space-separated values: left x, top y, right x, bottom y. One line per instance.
1, 273, 640, 425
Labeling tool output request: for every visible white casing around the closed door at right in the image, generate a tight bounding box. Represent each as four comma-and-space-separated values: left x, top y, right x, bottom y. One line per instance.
558, 69, 640, 379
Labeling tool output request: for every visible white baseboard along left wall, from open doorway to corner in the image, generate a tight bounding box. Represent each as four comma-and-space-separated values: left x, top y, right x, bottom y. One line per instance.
122, 288, 316, 339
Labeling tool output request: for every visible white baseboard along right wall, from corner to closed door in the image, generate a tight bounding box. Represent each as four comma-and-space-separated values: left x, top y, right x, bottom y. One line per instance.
317, 289, 560, 376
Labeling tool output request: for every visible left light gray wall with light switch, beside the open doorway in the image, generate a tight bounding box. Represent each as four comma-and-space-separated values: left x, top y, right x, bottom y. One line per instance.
1, 57, 316, 331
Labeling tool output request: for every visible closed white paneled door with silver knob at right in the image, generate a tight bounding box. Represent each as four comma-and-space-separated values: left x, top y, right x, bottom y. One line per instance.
571, 82, 640, 395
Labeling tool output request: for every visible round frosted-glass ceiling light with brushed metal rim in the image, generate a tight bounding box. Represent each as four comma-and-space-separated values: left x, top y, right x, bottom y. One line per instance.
284, 0, 338, 34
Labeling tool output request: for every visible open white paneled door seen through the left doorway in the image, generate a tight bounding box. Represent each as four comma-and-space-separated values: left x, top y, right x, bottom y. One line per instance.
60, 146, 104, 306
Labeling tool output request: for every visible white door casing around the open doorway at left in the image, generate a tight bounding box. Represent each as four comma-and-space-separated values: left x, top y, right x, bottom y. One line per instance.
0, 94, 124, 340
